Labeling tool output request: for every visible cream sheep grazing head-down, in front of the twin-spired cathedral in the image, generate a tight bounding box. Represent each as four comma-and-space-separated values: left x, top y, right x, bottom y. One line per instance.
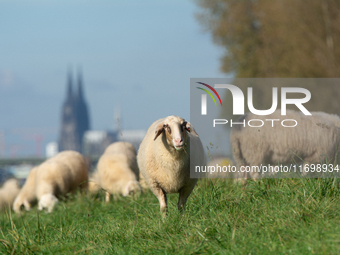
35, 151, 88, 213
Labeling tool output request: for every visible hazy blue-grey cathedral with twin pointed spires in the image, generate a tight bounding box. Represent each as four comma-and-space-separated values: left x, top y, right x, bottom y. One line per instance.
59, 68, 90, 152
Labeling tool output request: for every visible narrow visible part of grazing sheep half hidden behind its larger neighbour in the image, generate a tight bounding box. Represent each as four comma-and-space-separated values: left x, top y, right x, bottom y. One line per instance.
13, 167, 38, 213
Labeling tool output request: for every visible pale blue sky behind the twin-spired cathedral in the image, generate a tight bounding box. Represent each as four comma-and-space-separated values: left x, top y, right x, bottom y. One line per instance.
0, 0, 226, 156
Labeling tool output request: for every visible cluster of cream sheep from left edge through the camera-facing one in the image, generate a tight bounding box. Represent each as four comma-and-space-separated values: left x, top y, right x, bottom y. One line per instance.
0, 116, 205, 213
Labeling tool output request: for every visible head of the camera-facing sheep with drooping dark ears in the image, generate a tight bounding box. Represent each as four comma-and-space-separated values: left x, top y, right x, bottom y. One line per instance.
154, 116, 198, 150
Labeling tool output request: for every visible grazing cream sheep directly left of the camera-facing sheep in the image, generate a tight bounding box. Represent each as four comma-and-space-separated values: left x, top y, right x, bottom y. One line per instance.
97, 142, 141, 202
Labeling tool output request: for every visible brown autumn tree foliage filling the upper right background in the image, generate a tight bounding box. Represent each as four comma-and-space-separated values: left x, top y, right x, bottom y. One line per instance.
197, 0, 340, 116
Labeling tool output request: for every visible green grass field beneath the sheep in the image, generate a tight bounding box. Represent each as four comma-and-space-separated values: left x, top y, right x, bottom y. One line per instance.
0, 179, 340, 254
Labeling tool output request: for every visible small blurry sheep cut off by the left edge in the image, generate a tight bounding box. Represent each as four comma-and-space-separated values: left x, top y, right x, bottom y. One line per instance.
0, 179, 20, 211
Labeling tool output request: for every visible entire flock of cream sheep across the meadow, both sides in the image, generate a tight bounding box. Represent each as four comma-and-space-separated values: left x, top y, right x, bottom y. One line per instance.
0, 111, 340, 214
